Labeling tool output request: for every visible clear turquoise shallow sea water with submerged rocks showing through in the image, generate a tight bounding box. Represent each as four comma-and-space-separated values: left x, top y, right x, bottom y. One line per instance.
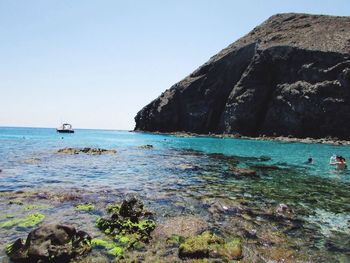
0, 128, 350, 262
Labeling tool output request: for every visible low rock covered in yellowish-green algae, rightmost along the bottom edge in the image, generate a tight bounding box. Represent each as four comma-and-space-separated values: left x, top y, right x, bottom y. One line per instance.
179, 231, 242, 261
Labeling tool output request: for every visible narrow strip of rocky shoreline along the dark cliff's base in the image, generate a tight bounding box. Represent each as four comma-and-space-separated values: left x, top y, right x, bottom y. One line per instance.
132, 130, 350, 146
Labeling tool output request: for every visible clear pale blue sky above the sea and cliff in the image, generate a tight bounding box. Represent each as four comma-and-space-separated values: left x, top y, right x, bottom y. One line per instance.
0, 0, 350, 129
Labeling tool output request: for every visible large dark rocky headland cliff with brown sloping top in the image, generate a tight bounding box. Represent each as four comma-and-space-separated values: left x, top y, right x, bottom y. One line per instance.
135, 14, 350, 139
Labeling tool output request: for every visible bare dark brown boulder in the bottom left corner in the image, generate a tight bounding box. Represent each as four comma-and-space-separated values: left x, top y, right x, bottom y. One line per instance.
6, 225, 91, 263
